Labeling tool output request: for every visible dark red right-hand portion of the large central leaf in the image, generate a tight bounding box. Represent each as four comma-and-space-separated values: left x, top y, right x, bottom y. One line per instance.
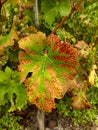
48, 34, 78, 79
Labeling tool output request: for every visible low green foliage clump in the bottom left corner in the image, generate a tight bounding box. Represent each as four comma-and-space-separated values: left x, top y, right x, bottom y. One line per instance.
0, 113, 23, 130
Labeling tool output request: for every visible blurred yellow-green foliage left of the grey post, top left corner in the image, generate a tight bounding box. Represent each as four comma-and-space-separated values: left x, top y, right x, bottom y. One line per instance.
1, 0, 36, 37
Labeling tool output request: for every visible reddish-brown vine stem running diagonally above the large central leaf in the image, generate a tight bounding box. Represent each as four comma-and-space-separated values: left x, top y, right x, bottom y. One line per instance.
51, 0, 83, 34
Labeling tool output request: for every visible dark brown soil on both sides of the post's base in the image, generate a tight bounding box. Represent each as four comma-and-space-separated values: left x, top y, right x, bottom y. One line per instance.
16, 106, 98, 130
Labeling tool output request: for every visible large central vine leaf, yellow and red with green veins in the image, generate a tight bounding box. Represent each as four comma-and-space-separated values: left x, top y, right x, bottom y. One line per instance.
18, 32, 78, 112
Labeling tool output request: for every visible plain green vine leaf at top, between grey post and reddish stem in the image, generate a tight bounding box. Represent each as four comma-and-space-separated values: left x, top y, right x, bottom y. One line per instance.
41, 0, 71, 25
